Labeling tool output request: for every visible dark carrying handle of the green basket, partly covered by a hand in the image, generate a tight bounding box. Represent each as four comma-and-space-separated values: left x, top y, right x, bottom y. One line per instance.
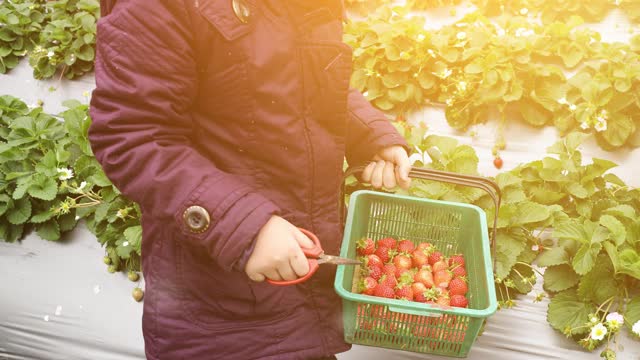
339, 166, 502, 271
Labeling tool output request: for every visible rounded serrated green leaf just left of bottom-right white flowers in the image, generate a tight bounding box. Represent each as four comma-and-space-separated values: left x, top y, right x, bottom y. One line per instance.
547, 289, 596, 335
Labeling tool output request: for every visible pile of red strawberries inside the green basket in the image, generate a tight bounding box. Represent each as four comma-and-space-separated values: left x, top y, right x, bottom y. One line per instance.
356, 237, 468, 308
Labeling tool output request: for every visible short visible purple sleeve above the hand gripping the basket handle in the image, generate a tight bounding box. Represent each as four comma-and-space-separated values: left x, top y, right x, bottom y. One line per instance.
346, 89, 410, 166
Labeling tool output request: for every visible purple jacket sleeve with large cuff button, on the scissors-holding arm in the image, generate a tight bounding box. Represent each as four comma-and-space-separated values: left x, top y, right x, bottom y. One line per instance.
89, 0, 279, 271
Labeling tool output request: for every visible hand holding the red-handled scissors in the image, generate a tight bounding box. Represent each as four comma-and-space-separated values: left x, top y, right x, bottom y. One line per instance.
245, 216, 313, 282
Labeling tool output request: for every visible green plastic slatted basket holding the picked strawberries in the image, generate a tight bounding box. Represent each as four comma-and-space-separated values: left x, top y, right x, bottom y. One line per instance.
335, 168, 500, 357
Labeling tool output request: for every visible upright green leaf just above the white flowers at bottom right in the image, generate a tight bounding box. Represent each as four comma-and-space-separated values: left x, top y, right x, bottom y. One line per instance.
578, 254, 618, 304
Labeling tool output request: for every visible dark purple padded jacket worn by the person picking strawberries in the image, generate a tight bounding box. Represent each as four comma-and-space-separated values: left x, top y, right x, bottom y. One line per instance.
89, 0, 406, 360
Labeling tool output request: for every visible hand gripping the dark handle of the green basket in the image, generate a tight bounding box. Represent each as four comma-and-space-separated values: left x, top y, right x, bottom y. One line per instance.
362, 145, 411, 189
